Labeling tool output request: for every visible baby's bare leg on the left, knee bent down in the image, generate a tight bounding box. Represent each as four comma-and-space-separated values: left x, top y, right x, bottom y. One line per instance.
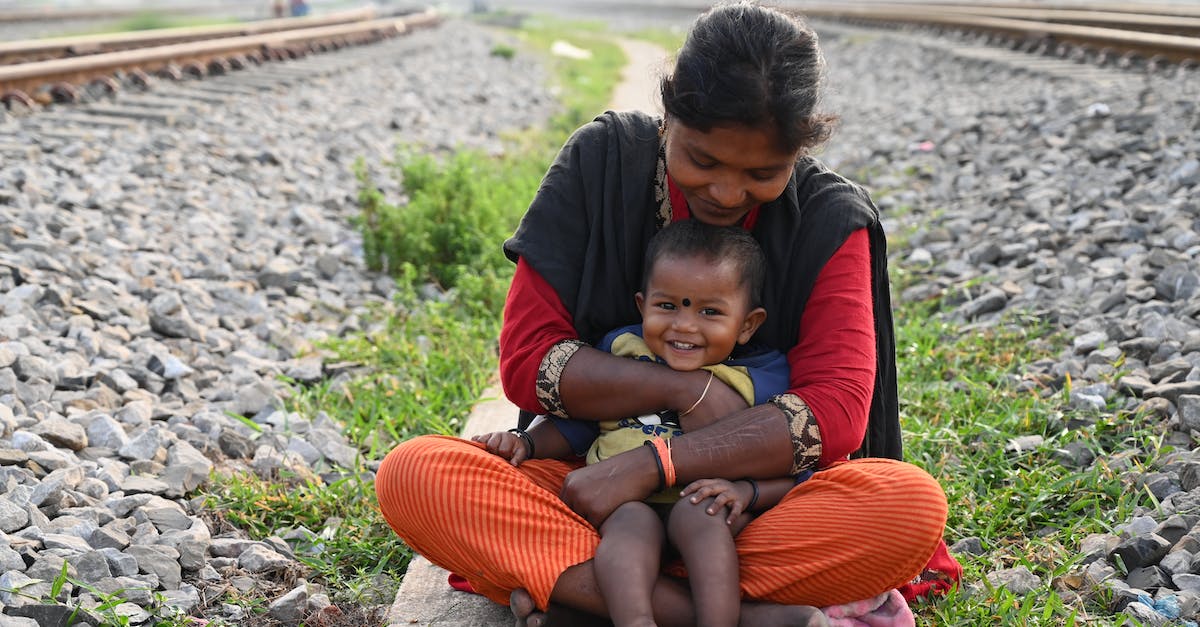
595, 501, 667, 627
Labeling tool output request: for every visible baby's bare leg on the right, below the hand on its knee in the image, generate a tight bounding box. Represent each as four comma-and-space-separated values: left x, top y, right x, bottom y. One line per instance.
667, 498, 750, 627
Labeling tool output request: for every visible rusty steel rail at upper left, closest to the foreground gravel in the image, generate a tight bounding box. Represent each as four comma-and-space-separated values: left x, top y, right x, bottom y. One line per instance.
0, 11, 440, 100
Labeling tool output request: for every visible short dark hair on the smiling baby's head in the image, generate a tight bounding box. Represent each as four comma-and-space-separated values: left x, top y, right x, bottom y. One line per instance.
642, 220, 767, 307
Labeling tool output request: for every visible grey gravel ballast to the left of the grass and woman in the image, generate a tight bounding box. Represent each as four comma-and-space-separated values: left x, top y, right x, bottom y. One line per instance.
0, 22, 556, 625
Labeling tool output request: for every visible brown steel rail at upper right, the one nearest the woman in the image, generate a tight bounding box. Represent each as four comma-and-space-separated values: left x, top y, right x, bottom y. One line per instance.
788, 4, 1200, 61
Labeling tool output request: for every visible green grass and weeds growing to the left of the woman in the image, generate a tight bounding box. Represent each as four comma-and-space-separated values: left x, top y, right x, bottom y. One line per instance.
192, 12, 624, 609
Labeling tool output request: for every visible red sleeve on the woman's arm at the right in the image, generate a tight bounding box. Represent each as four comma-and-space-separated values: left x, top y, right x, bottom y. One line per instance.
792, 228, 875, 467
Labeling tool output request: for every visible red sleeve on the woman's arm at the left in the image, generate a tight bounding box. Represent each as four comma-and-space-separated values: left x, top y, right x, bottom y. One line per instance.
500, 259, 578, 413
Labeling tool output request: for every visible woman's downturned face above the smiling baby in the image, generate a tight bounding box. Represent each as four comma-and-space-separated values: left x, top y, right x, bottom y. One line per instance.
666, 120, 799, 226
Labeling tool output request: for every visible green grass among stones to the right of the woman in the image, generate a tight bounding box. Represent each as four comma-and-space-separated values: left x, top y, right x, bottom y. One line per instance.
894, 265, 1166, 626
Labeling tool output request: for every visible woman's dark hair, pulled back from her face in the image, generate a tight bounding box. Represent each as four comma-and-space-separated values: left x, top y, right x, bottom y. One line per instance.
662, 0, 836, 151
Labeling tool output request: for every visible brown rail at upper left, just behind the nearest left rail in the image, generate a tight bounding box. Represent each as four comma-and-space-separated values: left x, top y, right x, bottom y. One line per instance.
0, 8, 376, 65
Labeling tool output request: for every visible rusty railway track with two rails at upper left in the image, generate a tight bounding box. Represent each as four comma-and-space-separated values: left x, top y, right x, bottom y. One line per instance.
0, 10, 439, 109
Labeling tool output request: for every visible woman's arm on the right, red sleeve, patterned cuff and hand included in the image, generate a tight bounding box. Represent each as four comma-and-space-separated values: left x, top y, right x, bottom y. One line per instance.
563, 231, 875, 524
